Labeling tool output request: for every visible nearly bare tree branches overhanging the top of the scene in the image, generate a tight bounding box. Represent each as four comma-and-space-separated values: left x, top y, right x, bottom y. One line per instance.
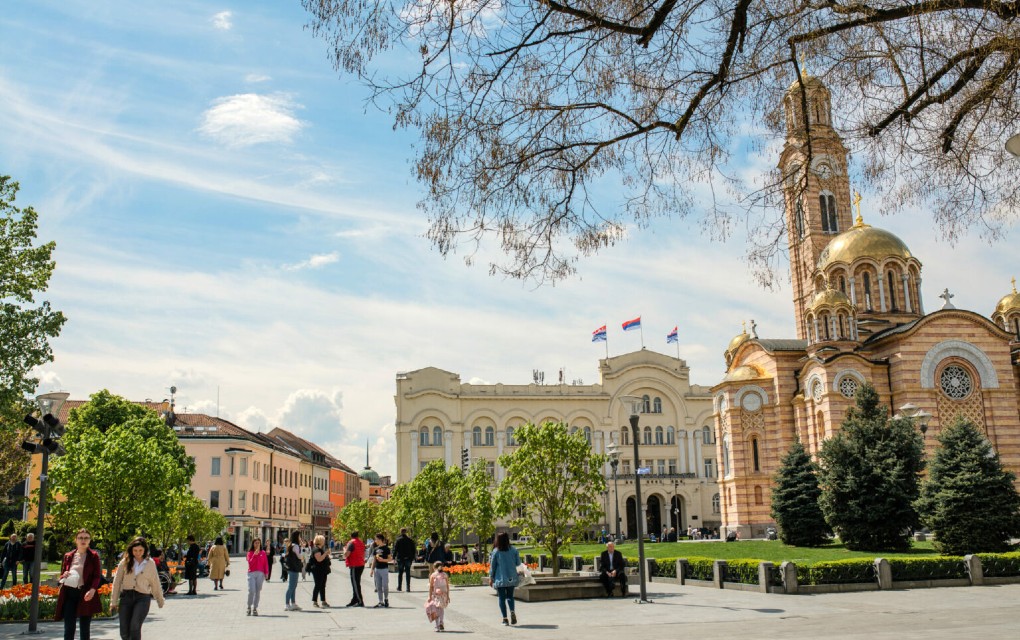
302, 0, 1020, 284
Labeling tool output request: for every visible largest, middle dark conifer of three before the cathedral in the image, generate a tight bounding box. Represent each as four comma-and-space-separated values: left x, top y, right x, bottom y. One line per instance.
818, 385, 924, 551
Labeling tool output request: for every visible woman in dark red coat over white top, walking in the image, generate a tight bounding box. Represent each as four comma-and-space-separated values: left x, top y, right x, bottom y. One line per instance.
55, 529, 103, 640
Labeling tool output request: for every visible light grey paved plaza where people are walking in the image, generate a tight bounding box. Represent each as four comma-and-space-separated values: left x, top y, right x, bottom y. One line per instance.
0, 558, 1020, 640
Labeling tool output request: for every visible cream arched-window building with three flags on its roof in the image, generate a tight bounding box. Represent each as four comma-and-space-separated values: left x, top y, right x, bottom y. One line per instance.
396, 349, 721, 538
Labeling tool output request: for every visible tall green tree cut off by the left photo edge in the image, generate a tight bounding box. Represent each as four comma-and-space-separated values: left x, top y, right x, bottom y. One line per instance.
0, 176, 66, 502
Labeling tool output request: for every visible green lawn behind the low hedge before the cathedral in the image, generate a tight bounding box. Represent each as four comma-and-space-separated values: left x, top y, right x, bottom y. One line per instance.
520, 540, 938, 565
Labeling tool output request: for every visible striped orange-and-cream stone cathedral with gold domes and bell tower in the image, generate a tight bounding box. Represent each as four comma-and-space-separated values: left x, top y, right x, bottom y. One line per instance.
712, 71, 1020, 537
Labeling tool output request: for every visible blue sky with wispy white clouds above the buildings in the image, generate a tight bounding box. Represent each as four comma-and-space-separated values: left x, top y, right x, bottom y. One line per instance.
0, 0, 1017, 481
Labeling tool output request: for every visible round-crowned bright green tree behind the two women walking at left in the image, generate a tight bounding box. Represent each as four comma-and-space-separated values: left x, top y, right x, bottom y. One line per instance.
50, 394, 194, 575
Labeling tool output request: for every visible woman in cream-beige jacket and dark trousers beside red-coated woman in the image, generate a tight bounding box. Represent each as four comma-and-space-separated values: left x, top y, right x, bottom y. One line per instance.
110, 537, 163, 640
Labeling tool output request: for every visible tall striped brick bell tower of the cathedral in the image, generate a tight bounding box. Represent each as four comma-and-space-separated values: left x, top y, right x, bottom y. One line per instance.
779, 71, 853, 340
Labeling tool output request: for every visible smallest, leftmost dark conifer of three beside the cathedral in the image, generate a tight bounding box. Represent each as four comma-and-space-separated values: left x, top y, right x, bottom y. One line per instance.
772, 439, 830, 547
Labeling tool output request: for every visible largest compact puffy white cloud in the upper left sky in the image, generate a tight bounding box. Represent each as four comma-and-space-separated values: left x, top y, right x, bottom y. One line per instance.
198, 93, 304, 147
